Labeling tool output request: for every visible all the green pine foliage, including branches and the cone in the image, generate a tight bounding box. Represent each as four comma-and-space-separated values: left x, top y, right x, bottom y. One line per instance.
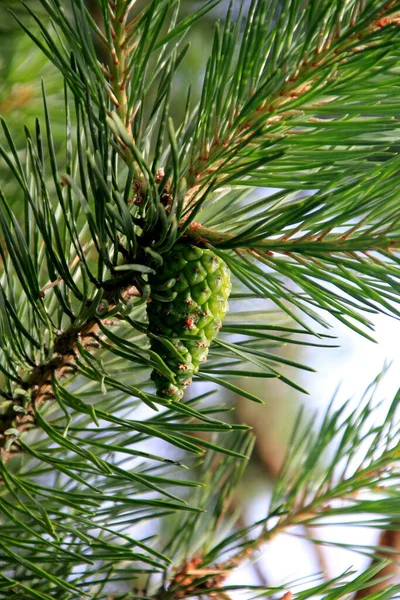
0, 0, 400, 600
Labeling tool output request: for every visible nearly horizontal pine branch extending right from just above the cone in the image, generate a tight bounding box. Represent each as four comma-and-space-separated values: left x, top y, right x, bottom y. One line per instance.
184, 145, 399, 332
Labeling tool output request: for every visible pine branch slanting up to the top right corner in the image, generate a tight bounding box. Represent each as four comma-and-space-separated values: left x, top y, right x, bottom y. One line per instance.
180, 2, 399, 195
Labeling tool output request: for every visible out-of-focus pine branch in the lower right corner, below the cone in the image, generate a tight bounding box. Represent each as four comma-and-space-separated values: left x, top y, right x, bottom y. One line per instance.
152, 379, 399, 598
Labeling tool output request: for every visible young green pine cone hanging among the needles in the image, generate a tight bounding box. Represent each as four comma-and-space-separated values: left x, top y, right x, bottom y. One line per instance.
147, 243, 231, 400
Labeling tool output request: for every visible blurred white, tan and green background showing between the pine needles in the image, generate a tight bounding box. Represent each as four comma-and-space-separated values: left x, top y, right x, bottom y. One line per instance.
0, 0, 400, 585
